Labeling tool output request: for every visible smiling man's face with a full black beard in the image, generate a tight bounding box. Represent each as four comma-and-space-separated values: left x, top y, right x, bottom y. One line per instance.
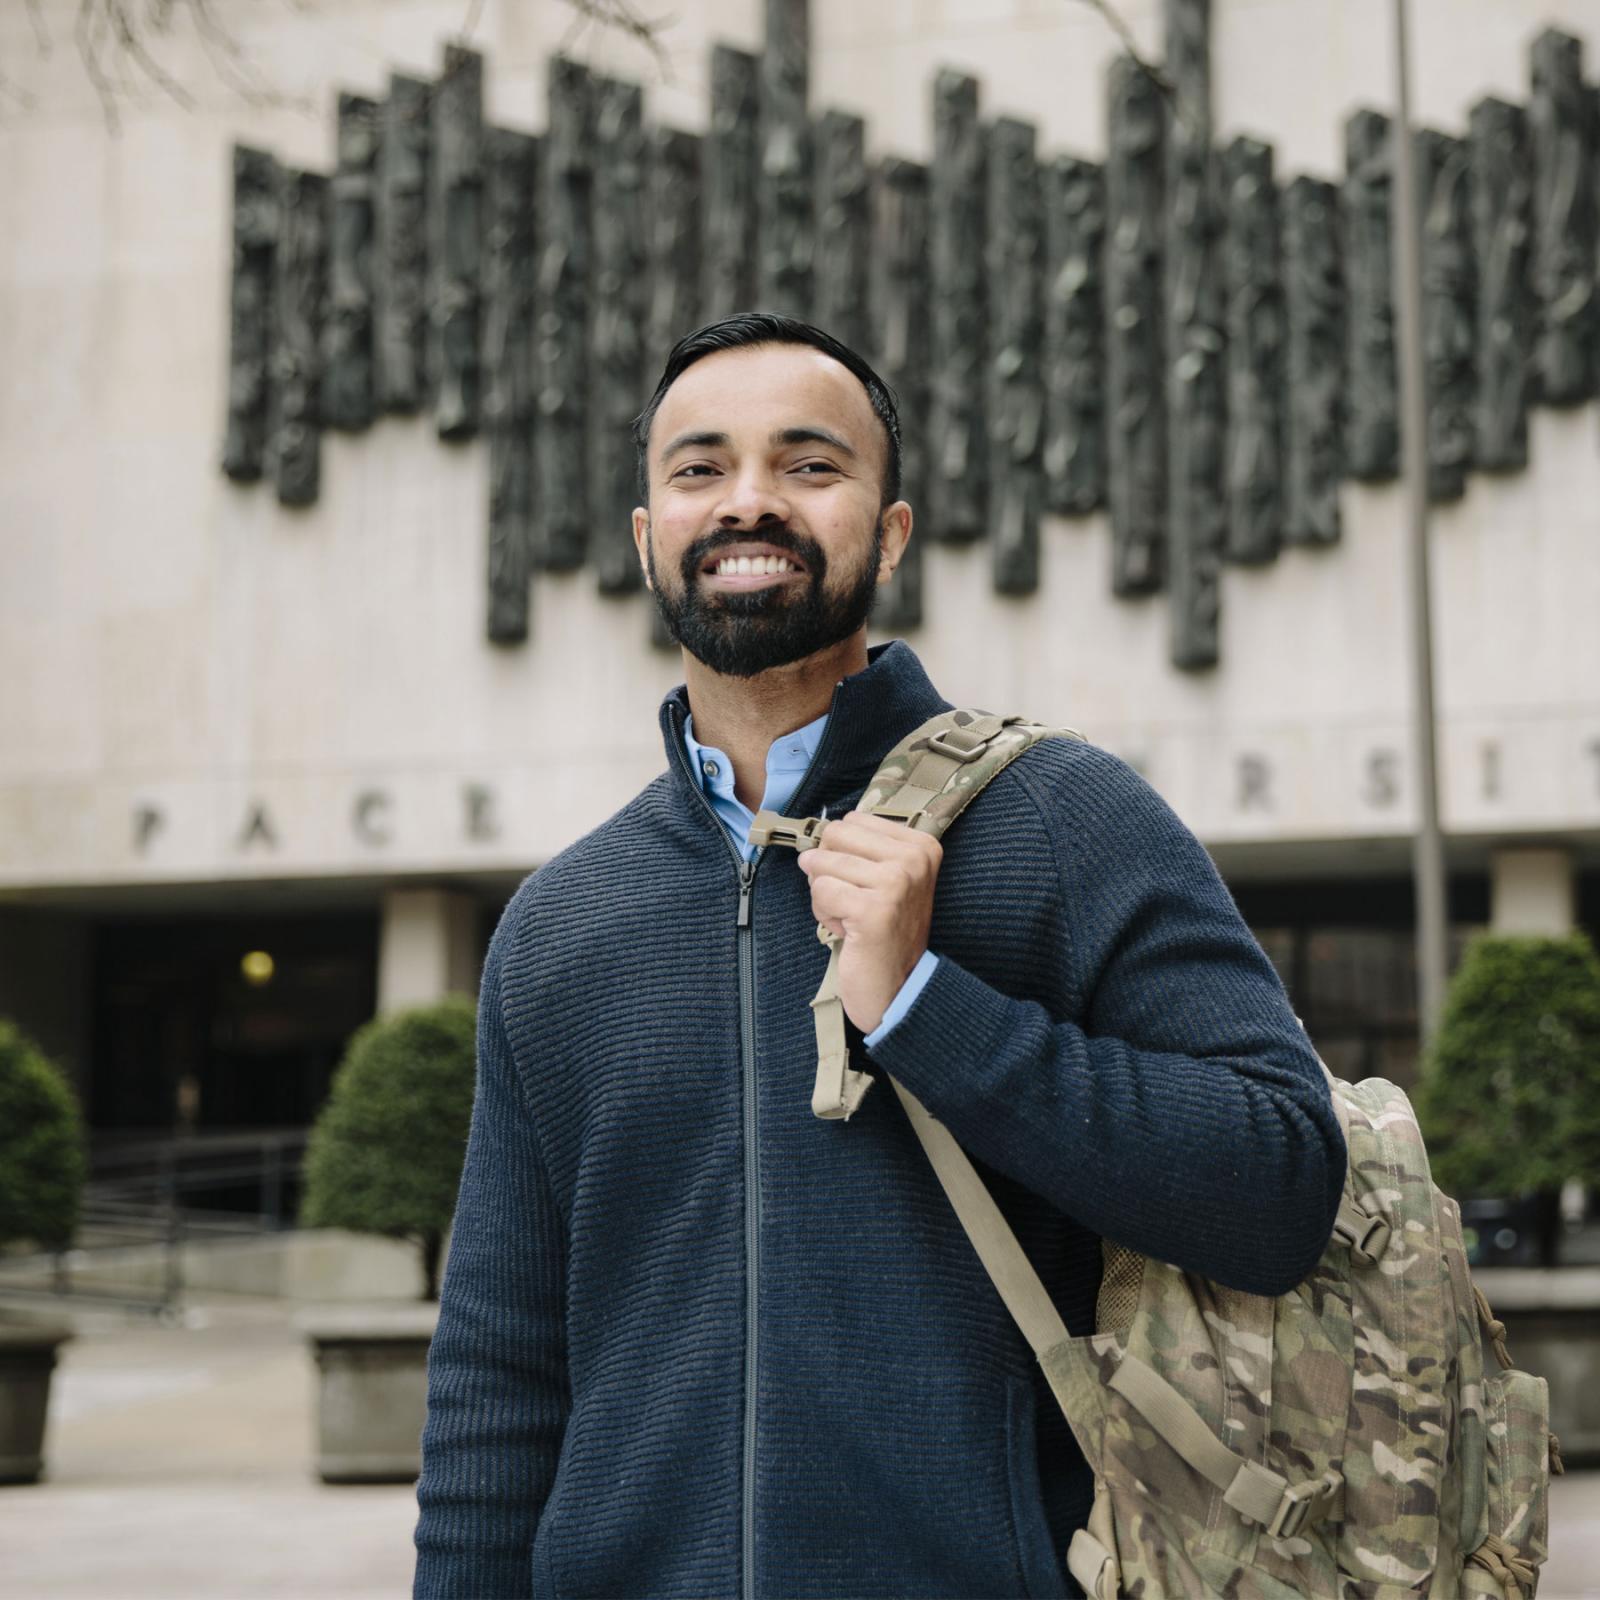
634, 344, 910, 678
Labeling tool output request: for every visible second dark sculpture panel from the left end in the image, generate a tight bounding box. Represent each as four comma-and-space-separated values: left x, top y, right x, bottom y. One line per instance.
269, 170, 328, 506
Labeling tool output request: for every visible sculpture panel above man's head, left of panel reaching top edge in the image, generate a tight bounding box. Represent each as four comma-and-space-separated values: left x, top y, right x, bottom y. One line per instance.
704, 45, 762, 322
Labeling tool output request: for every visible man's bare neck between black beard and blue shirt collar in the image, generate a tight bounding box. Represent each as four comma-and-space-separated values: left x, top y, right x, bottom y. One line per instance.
683, 627, 867, 811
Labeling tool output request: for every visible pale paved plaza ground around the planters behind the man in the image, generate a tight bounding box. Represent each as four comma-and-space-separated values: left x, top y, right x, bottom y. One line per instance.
0, 1299, 1600, 1600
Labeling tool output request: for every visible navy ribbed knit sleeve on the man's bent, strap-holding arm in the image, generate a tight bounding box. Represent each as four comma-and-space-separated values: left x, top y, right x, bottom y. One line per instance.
872, 746, 1346, 1294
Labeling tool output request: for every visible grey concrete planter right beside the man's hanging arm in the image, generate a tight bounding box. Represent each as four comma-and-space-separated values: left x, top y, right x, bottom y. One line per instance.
296, 1304, 438, 1483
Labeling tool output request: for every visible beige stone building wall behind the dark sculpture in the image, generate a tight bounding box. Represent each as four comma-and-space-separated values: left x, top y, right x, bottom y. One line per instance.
0, 0, 1600, 891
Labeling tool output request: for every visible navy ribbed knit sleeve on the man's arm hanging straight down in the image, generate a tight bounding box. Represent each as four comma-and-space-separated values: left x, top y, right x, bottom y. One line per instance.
413, 921, 570, 1600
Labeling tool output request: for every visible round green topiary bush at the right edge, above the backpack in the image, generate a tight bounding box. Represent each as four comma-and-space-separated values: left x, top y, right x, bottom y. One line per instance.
1416, 933, 1600, 1198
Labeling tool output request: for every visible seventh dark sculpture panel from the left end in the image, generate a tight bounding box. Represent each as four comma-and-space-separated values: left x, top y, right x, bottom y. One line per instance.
533, 56, 594, 571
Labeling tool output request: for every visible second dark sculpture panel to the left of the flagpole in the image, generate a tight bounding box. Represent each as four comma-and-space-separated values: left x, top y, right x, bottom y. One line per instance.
1283, 178, 1346, 544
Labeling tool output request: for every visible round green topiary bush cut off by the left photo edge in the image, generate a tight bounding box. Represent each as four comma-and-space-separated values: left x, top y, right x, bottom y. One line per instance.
0, 1018, 88, 1250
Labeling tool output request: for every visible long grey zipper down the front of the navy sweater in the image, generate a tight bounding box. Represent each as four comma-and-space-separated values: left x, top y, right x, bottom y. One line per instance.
672, 717, 834, 1600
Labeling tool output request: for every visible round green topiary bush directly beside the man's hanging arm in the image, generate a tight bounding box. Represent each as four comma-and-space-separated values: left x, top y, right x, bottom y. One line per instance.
299, 995, 477, 1301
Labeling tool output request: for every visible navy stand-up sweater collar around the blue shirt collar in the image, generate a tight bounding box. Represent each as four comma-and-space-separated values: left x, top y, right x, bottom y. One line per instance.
661, 638, 950, 816
